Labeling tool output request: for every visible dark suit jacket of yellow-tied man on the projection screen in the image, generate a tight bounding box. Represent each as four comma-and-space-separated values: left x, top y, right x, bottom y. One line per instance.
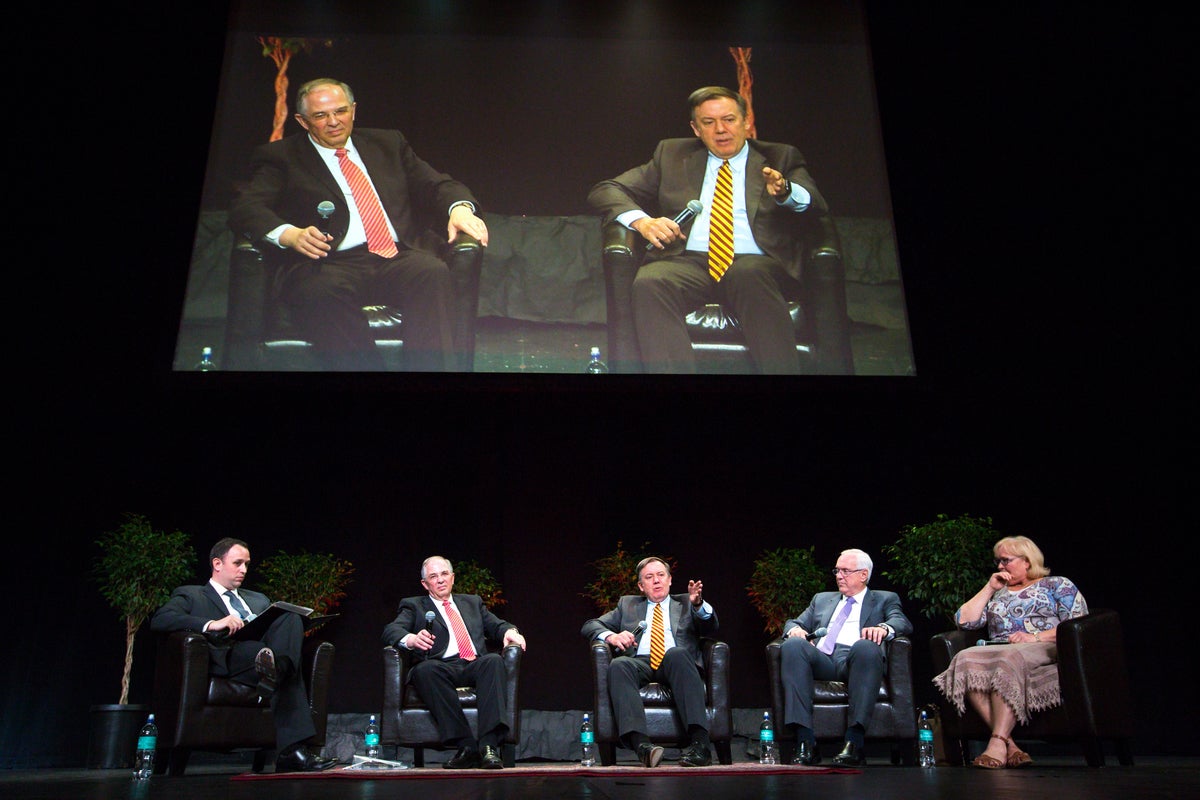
588, 138, 829, 281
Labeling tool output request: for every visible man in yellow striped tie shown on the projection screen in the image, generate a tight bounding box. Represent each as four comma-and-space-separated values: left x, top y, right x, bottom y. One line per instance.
588, 86, 829, 374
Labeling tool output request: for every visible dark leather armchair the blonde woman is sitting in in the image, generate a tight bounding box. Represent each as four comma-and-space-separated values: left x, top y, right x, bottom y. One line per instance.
930, 609, 1134, 766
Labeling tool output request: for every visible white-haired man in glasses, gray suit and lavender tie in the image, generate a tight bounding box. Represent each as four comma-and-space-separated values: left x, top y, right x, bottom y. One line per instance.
781, 549, 912, 766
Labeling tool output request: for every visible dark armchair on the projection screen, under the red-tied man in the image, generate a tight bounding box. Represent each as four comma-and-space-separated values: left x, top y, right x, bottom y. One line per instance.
223, 234, 482, 372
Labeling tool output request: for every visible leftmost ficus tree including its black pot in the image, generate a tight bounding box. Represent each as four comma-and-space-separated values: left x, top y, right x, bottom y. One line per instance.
88, 513, 196, 769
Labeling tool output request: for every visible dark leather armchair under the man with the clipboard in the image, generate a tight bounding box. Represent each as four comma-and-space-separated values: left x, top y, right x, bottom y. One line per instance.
154, 632, 334, 775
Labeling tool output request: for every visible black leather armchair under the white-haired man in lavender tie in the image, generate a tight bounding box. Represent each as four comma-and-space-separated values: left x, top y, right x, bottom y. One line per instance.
767, 636, 917, 765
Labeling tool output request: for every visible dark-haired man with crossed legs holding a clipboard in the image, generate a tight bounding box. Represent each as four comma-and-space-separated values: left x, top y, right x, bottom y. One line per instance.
150, 537, 337, 772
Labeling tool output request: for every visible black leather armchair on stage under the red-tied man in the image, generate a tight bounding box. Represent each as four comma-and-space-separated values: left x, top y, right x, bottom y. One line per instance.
379, 644, 524, 766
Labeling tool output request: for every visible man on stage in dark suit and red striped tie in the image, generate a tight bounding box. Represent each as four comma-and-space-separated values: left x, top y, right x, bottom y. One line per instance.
383, 555, 526, 770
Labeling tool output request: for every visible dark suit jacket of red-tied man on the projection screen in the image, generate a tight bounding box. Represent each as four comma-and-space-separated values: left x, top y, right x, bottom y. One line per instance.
229, 128, 479, 263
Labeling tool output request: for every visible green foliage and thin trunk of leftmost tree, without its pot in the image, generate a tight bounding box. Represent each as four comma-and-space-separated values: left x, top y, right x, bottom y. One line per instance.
92, 513, 196, 705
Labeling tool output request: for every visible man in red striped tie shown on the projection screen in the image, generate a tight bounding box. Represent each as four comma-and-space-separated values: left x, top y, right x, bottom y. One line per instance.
229, 78, 487, 372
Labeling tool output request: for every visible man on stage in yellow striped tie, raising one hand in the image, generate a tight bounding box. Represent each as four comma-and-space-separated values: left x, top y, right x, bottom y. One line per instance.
581, 557, 716, 766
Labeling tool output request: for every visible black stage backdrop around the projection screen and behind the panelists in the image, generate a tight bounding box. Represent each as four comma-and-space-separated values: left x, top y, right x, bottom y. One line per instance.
7, 0, 1196, 768
